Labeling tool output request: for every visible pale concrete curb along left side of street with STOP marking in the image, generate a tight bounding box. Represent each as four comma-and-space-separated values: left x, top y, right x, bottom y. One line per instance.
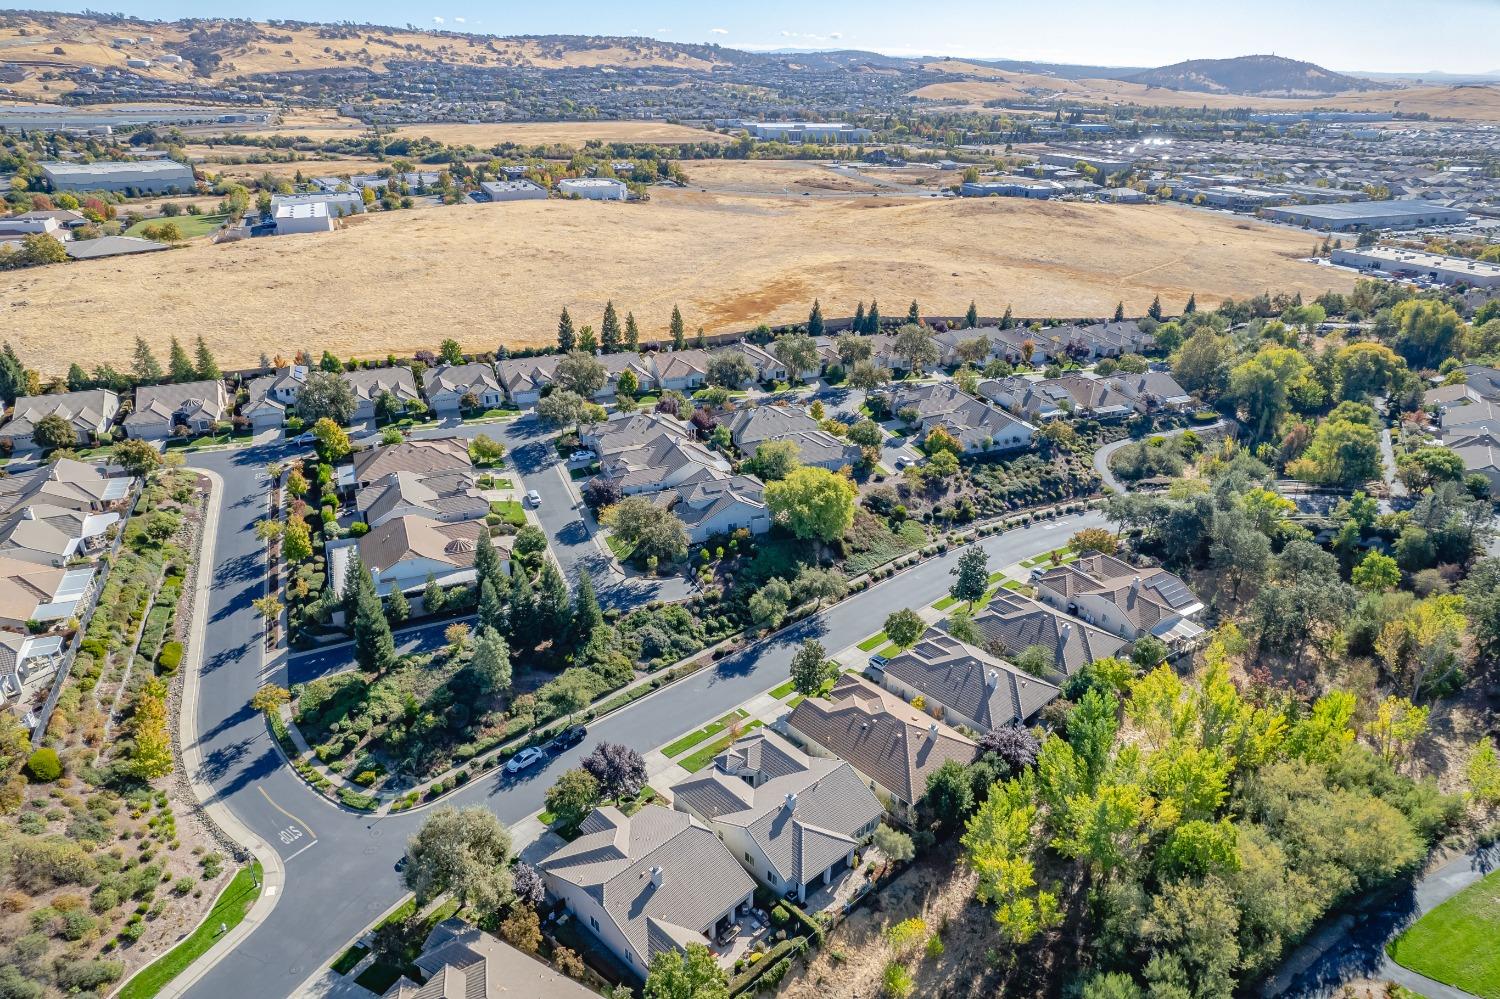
141, 468, 287, 999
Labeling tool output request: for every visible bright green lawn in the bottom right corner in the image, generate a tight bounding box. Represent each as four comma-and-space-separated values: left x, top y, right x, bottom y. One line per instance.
1386, 872, 1500, 999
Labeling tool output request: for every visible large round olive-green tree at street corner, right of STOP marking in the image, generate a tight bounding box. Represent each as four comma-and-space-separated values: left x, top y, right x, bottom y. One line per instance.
401, 806, 515, 917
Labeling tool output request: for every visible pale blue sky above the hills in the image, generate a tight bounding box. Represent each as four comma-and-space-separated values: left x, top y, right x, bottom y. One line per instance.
24, 0, 1500, 74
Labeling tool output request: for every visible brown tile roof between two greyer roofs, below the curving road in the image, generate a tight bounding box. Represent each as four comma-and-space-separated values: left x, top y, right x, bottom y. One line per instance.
788, 674, 978, 804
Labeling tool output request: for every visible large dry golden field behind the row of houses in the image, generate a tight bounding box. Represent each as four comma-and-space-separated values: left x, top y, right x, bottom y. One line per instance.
0, 191, 1352, 372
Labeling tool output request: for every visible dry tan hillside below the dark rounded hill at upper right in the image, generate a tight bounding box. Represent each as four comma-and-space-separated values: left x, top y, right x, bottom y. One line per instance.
912, 70, 1500, 122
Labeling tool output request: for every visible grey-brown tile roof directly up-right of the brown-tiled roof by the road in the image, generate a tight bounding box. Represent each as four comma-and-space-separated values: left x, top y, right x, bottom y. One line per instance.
881, 629, 1061, 731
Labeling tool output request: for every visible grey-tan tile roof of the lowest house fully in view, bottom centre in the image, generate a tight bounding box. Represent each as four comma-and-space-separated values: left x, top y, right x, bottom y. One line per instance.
539, 806, 755, 963
